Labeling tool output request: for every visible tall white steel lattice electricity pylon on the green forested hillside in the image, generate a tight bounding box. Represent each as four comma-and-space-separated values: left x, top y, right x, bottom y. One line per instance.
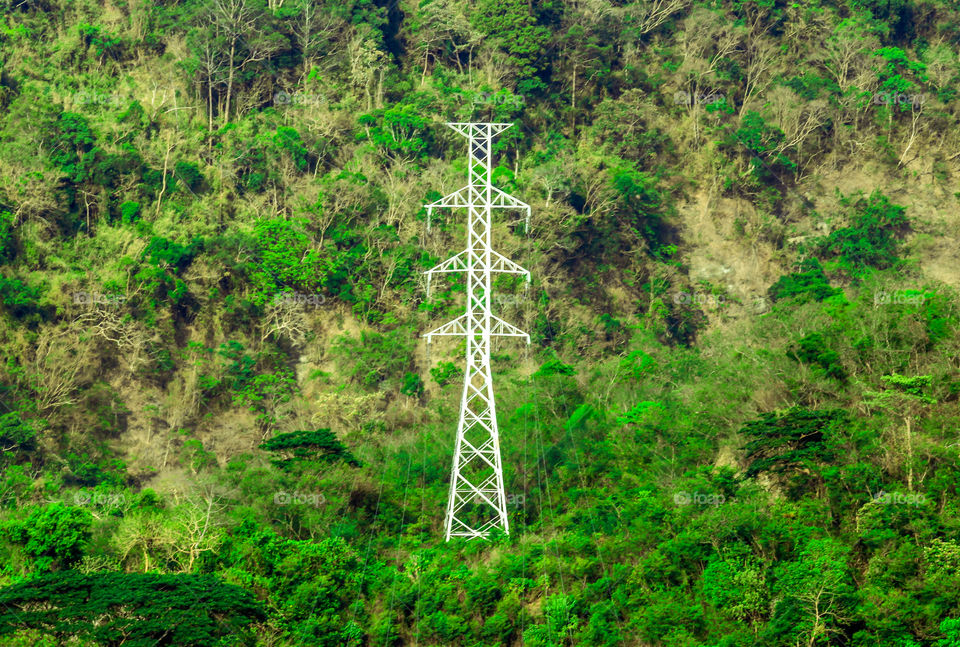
424, 123, 530, 541
